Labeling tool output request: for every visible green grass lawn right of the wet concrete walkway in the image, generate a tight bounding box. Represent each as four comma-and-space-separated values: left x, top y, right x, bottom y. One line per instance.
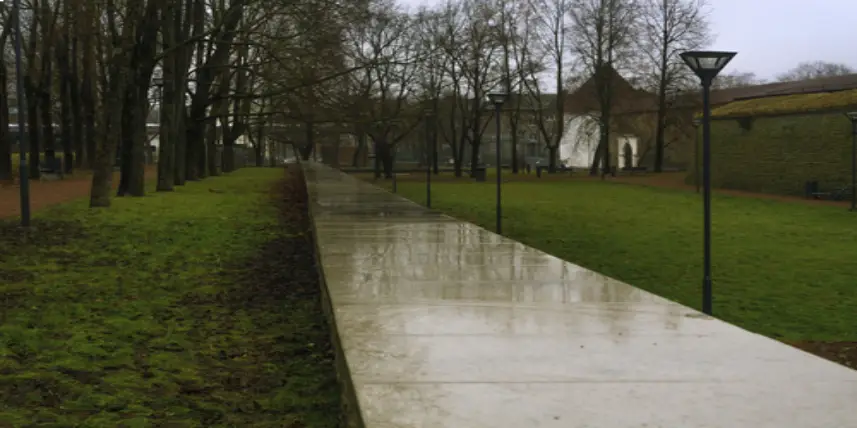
386, 181, 857, 341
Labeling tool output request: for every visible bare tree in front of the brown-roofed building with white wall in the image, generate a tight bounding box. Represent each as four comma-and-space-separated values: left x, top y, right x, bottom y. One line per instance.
569, 0, 639, 175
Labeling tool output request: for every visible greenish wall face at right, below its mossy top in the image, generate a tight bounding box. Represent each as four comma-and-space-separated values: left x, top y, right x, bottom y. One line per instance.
687, 113, 851, 196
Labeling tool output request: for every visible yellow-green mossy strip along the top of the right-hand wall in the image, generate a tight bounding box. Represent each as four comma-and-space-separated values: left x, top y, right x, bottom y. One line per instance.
711, 89, 857, 118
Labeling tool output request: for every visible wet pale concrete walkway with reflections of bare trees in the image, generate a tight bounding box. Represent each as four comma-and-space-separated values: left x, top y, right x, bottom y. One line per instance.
306, 164, 857, 428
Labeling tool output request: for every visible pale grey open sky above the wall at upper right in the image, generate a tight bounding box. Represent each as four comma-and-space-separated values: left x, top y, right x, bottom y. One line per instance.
398, 0, 857, 79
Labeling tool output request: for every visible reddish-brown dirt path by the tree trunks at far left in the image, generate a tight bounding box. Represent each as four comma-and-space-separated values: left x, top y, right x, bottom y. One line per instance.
0, 167, 156, 219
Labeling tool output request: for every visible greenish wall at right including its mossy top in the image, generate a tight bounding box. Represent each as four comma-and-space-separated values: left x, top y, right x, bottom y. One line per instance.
686, 90, 857, 196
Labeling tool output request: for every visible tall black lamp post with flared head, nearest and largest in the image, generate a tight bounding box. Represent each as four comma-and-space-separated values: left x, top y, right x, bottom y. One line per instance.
681, 51, 736, 315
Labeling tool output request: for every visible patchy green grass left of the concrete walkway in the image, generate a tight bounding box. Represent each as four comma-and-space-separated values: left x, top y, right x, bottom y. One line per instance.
0, 168, 339, 427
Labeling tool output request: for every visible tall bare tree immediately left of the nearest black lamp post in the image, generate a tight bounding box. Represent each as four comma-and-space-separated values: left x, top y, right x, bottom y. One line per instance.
638, 0, 710, 172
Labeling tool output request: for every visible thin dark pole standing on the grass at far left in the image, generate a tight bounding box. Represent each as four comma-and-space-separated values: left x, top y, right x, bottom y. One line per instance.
12, 0, 30, 227
